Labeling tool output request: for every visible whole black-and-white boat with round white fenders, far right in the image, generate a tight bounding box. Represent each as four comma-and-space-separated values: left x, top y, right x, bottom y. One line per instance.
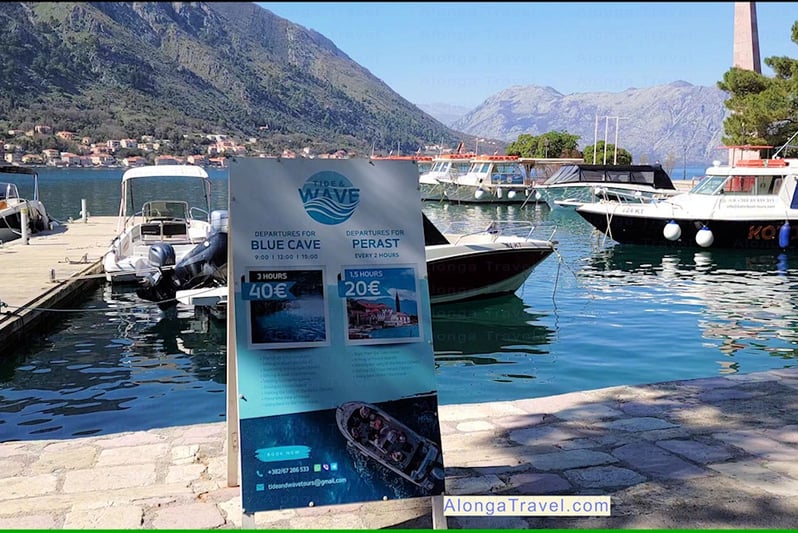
576, 159, 798, 249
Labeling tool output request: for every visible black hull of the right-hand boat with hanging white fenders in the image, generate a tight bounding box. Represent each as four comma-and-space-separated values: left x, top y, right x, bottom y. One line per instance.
577, 207, 798, 249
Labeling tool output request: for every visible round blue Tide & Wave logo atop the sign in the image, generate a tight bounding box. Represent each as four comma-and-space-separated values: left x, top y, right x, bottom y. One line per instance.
299, 170, 360, 226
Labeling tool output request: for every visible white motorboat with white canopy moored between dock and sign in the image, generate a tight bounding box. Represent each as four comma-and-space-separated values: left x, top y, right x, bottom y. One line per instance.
102, 165, 216, 283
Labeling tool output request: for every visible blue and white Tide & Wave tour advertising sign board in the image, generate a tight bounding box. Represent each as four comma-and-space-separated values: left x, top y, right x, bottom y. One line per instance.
228, 158, 444, 513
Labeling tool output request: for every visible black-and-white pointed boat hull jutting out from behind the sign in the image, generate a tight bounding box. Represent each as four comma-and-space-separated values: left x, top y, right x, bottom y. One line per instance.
427, 244, 554, 304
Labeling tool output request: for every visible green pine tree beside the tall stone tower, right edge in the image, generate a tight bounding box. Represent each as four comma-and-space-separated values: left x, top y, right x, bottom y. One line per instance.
718, 21, 798, 155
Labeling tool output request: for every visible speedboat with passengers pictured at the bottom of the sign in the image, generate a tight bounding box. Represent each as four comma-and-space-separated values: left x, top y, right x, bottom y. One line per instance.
335, 402, 444, 491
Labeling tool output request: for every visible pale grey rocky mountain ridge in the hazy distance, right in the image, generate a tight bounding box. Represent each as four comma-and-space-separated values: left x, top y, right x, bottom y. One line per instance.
450, 81, 728, 164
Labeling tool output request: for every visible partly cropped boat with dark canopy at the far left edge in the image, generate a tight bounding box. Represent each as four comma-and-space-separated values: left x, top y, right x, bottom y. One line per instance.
0, 165, 51, 242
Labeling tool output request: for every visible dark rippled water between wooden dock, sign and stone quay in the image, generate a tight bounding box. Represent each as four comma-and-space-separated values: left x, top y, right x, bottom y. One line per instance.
0, 286, 226, 442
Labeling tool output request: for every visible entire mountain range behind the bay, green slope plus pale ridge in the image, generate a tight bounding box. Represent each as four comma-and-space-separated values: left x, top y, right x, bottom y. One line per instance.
0, 2, 726, 164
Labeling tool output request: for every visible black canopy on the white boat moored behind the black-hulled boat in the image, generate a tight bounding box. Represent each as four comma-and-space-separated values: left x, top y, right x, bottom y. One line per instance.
543, 165, 676, 190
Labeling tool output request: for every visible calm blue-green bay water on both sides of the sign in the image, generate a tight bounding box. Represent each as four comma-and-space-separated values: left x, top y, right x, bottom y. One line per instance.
6, 169, 798, 442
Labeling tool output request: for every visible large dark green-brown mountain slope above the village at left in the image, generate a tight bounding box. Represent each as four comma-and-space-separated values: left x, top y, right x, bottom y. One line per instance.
0, 2, 462, 152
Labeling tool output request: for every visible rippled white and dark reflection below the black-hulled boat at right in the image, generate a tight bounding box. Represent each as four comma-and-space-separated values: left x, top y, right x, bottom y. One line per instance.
580, 246, 798, 366
